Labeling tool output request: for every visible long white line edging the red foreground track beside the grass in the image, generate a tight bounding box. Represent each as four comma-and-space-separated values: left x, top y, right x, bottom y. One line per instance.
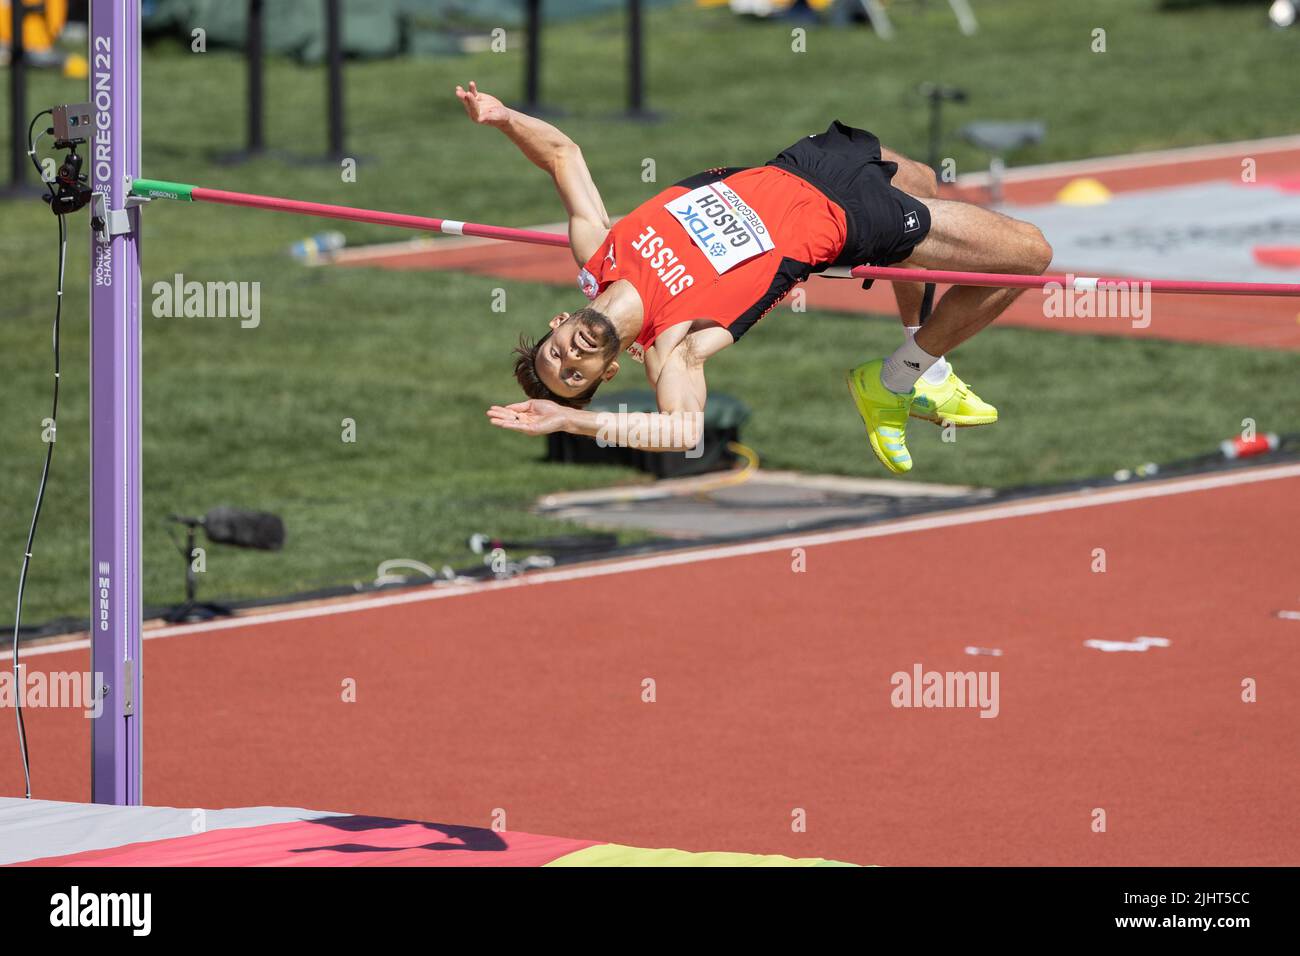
0, 464, 1300, 661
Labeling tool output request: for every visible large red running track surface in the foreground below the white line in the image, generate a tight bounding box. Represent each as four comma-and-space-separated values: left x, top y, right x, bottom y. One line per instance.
0, 466, 1300, 865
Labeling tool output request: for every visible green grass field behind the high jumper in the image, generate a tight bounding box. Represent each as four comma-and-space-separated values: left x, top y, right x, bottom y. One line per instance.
0, 0, 1300, 622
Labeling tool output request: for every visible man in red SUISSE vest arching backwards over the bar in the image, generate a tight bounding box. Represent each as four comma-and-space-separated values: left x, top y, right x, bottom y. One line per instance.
456, 82, 1052, 473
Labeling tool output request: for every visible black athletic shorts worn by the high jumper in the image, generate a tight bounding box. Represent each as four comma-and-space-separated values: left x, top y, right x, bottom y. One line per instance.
767, 120, 930, 265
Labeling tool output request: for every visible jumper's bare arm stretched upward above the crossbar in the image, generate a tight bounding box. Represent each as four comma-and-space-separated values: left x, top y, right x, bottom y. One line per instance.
456, 81, 610, 265
